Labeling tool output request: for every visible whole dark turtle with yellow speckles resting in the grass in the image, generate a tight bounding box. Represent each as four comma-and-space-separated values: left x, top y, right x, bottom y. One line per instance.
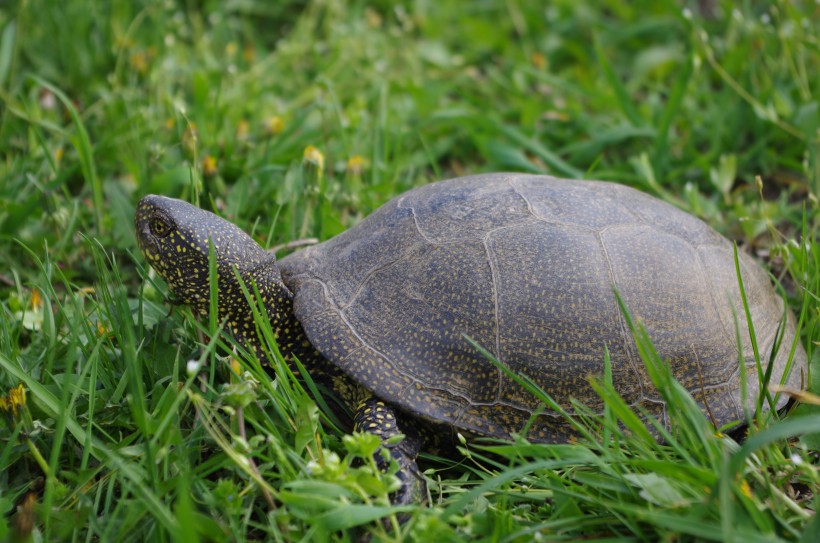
135, 173, 807, 503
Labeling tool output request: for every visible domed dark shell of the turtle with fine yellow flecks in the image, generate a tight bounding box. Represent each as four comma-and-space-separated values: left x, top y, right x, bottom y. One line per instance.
280, 174, 806, 442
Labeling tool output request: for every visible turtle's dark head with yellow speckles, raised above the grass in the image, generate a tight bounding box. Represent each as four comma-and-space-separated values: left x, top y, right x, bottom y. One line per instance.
134, 195, 281, 317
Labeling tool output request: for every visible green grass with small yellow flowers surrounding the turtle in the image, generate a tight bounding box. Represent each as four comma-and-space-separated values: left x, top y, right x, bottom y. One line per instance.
0, 0, 820, 542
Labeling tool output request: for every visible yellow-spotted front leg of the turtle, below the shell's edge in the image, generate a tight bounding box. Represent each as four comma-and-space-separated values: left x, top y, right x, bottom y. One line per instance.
353, 396, 427, 505
